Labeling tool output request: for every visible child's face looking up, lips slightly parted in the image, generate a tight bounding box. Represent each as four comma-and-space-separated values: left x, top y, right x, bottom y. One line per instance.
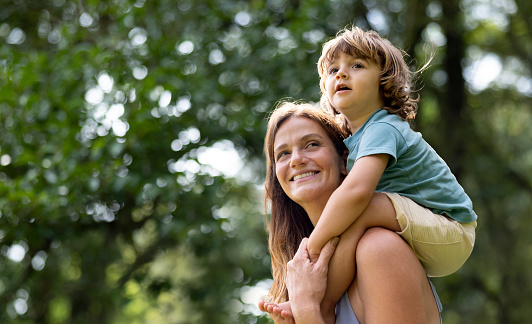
325, 52, 383, 130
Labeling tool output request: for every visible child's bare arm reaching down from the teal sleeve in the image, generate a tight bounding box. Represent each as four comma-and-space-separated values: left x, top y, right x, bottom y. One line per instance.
308, 154, 390, 260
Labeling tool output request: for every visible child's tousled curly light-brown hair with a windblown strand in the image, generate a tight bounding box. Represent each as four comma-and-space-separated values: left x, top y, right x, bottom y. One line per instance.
318, 26, 430, 120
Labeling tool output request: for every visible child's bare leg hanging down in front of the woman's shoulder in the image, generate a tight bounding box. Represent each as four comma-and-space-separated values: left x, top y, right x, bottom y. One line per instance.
321, 193, 400, 323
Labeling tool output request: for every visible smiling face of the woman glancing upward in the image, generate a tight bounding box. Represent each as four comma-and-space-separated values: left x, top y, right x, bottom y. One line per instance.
273, 117, 347, 208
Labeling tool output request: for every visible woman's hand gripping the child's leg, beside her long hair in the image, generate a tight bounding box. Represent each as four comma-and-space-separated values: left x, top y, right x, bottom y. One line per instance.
286, 237, 339, 323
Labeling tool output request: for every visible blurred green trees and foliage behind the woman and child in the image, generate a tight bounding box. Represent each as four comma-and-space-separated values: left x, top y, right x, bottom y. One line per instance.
0, 0, 532, 324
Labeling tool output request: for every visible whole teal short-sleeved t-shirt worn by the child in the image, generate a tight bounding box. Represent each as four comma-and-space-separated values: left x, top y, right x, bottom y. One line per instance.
344, 109, 477, 223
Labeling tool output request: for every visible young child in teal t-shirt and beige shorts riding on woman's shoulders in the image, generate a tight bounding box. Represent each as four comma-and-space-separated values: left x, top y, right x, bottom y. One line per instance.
264, 27, 477, 322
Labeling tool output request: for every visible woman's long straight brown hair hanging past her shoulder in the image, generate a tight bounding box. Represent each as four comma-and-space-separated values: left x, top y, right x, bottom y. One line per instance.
264, 102, 348, 303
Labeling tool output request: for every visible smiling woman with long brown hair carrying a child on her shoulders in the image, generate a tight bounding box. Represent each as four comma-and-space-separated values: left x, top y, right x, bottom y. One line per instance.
259, 103, 440, 323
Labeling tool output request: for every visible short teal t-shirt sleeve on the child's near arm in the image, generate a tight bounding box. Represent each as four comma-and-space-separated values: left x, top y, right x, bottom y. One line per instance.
356, 123, 404, 167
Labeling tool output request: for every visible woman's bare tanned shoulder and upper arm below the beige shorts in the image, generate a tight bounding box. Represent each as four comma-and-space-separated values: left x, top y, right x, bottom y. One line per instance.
349, 228, 440, 323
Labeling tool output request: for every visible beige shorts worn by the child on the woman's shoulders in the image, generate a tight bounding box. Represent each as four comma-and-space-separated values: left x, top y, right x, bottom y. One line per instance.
384, 192, 477, 277
